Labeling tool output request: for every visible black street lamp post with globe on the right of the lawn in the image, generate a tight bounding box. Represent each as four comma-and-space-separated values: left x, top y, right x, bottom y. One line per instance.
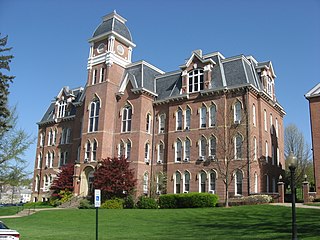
287, 152, 298, 240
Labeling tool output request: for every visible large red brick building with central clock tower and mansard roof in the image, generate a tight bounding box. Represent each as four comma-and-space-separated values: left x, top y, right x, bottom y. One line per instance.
33, 12, 285, 201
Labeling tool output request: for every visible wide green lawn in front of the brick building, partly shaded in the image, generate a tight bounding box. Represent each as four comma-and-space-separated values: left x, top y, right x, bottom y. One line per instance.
0, 205, 320, 240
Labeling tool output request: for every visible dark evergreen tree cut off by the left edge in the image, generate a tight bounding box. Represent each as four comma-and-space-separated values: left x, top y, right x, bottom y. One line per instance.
0, 33, 14, 135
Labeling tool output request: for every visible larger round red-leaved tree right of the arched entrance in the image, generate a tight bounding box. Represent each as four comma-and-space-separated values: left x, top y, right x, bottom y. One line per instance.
93, 157, 136, 199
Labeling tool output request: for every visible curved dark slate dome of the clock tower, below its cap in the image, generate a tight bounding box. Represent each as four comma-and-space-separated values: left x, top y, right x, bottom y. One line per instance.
92, 17, 132, 42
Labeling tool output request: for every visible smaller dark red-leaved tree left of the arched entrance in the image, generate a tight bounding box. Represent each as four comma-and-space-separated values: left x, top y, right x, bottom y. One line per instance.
50, 163, 74, 198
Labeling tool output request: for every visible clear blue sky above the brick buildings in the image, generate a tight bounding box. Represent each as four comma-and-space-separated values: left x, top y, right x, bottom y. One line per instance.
0, 0, 320, 173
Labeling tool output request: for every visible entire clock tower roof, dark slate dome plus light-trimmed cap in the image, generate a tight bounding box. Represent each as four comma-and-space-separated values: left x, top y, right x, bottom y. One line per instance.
92, 11, 132, 42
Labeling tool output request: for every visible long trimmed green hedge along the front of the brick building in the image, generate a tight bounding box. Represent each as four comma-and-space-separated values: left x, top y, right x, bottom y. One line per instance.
159, 193, 218, 208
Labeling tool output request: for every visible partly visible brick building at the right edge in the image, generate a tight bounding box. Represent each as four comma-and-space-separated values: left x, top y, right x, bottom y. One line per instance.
305, 83, 320, 197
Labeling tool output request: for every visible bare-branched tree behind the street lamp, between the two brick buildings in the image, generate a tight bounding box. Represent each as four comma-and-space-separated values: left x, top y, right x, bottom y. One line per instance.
284, 124, 313, 187
